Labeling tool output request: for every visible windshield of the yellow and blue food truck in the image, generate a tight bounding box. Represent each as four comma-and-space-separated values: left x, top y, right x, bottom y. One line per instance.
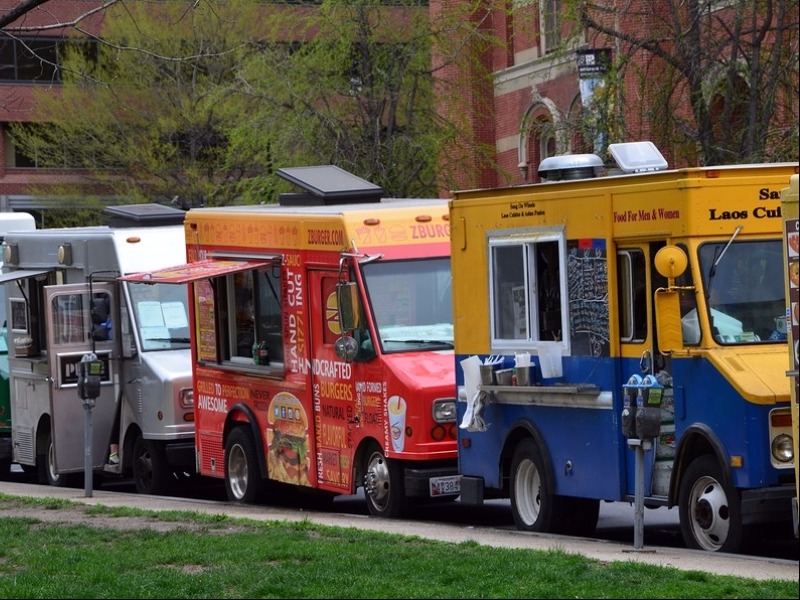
699, 239, 786, 344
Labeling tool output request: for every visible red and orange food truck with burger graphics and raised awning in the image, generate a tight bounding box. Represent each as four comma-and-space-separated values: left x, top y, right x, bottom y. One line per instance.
118, 166, 460, 517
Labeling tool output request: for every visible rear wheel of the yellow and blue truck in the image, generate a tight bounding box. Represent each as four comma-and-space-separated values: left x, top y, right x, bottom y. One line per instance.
511, 438, 557, 532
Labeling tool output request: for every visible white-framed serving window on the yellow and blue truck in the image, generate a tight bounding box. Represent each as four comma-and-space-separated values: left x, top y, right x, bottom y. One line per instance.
489, 232, 569, 348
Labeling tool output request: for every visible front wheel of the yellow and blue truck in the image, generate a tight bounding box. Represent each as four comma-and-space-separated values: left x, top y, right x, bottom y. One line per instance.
678, 455, 744, 552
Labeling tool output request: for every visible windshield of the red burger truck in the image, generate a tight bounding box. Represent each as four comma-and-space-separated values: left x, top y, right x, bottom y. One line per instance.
362, 257, 453, 353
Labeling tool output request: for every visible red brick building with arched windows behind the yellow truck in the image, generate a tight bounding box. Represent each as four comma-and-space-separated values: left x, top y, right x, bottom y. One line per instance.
430, 0, 800, 189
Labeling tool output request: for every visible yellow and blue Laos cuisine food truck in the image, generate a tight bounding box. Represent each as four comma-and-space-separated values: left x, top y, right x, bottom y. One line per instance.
450, 142, 798, 552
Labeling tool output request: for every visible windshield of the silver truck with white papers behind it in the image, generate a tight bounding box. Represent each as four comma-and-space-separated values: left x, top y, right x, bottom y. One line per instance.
126, 282, 191, 352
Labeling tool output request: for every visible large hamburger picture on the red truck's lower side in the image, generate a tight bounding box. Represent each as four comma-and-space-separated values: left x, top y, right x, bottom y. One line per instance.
267, 392, 309, 485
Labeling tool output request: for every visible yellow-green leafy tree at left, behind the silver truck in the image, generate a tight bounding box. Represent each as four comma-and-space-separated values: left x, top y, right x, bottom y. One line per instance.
12, 0, 284, 206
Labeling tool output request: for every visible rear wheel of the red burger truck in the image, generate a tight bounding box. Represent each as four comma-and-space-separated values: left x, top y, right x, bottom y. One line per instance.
225, 427, 266, 504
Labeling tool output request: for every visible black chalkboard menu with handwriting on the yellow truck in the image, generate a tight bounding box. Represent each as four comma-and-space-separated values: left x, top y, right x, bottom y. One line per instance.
567, 239, 611, 356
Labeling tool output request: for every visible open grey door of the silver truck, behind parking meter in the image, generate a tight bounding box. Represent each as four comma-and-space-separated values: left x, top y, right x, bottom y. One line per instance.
44, 283, 120, 473
